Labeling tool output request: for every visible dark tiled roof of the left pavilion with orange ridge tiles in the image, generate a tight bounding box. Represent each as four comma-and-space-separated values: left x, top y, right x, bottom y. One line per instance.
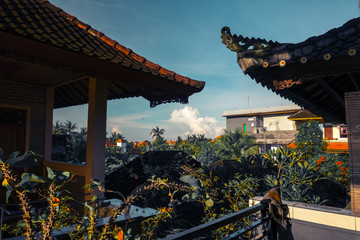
0, 0, 205, 107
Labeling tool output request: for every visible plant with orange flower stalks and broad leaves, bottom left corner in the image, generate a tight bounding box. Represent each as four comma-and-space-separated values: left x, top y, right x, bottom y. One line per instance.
0, 149, 75, 240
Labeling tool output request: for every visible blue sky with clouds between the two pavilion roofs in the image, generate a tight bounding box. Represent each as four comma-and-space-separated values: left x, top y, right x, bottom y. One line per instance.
50, 0, 359, 141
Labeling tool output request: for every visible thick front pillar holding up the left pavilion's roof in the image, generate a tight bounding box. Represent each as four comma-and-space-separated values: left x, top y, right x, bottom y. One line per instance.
85, 77, 107, 197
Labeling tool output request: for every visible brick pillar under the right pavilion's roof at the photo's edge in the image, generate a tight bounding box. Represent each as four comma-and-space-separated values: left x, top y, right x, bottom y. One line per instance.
345, 91, 360, 216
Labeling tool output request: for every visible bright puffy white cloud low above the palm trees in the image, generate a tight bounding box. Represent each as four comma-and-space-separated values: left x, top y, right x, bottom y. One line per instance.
168, 106, 223, 138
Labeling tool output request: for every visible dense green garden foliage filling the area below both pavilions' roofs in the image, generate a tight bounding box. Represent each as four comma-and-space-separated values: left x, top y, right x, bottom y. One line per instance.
0, 122, 349, 239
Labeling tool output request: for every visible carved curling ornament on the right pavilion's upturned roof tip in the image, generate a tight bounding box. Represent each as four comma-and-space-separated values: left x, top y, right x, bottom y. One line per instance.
221, 27, 281, 53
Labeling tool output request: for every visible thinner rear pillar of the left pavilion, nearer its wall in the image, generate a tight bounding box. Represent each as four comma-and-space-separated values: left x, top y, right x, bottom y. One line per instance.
44, 87, 54, 160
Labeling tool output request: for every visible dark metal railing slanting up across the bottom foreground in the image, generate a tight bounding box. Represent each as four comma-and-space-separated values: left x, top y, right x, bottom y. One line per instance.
163, 199, 277, 240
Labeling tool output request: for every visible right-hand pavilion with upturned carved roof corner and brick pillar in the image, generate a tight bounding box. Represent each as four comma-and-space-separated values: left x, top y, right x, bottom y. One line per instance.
221, 18, 360, 215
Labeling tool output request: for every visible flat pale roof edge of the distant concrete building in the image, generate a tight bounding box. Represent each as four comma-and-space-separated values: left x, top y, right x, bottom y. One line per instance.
222, 105, 301, 117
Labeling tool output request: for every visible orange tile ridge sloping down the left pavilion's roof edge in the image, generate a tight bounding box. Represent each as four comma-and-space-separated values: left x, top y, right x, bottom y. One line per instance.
40, 0, 205, 88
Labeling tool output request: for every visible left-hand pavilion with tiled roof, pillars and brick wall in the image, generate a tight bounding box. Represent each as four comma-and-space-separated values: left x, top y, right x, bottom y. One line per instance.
0, 0, 205, 202
